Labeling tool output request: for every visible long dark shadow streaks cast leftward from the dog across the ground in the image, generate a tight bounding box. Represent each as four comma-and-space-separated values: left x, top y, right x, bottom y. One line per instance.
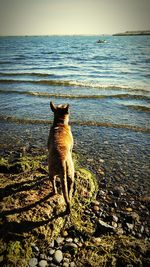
0, 177, 66, 243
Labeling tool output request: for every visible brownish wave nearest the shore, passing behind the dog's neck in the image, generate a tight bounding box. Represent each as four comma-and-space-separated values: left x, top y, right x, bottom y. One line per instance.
0, 115, 150, 133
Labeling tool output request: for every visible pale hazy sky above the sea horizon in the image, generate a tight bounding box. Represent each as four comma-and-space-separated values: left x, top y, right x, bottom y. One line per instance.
0, 0, 150, 35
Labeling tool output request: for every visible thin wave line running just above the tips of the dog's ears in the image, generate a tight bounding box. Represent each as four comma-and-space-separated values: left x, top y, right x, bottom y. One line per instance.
0, 89, 149, 101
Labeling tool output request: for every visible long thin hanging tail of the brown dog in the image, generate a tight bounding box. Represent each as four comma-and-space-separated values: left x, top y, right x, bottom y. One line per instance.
61, 161, 70, 213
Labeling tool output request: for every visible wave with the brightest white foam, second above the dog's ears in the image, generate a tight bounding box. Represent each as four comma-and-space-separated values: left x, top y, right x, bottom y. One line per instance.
0, 78, 149, 92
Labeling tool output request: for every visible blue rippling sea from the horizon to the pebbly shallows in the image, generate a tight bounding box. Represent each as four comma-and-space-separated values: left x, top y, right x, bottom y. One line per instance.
0, 36, 150, 194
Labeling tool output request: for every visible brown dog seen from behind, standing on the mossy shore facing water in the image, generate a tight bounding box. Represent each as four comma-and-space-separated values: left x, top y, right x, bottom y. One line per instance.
48, 102, 74, 213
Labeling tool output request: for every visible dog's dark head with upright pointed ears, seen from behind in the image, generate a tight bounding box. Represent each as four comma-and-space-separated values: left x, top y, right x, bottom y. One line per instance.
50, 102, 69, 123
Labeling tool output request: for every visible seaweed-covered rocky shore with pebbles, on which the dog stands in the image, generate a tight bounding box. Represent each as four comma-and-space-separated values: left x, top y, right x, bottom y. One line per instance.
0, 147, 150, 267
